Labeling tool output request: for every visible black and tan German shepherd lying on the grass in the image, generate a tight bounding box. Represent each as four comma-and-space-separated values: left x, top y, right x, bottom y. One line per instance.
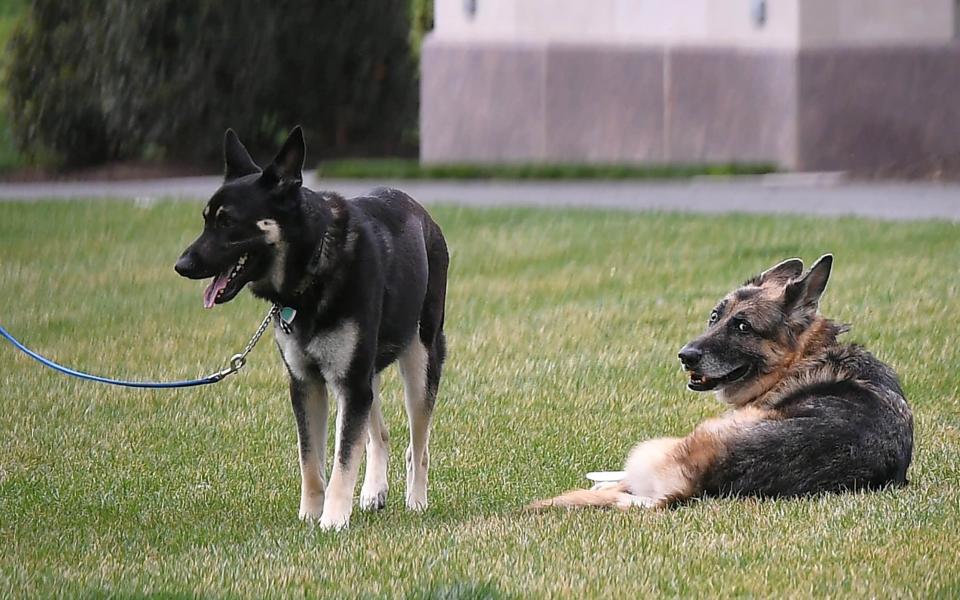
532, 255, 913, 509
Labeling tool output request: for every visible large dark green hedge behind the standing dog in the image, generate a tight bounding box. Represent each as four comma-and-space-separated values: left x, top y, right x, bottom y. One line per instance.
6, 0, 417, 166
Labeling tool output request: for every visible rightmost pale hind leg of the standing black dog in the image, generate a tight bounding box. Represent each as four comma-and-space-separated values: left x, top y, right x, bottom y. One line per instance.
397, 338, 439, 511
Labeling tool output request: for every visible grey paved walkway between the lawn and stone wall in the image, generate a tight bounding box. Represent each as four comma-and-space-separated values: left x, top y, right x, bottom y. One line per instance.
0, 174, 960, 222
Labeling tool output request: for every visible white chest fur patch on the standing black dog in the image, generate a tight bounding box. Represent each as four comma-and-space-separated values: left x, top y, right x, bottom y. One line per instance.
275, 321, 358, 382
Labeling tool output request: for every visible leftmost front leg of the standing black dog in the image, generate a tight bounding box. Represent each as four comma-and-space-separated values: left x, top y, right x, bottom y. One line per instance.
290, 376, 328, 520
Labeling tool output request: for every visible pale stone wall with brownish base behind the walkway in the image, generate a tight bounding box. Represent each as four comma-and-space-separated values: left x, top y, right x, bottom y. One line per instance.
421, 0, 960, 170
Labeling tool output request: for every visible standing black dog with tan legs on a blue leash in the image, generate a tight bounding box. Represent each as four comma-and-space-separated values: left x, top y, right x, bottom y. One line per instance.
176, 127, 448, 529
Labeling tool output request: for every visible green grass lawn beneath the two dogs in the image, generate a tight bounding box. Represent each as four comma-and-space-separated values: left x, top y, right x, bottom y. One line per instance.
0, 202, 960, 598
